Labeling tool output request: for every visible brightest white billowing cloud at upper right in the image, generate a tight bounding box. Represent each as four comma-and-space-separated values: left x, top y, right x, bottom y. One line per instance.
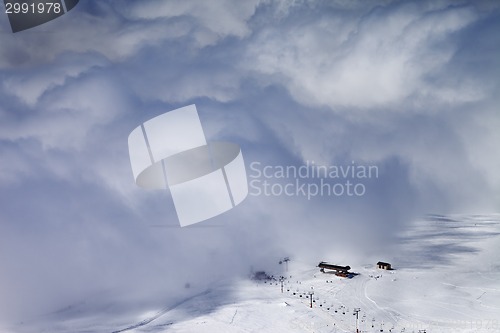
243, 3, 481, 108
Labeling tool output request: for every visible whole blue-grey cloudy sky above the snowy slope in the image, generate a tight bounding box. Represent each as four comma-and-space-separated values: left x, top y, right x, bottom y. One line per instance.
0, 0, 500, 323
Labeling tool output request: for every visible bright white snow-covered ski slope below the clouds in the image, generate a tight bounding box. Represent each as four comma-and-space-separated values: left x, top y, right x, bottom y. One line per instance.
0, 215, 500, 333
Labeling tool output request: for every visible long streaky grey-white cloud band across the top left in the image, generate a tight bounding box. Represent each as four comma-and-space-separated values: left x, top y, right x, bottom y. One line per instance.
0, 0, 259, 68
